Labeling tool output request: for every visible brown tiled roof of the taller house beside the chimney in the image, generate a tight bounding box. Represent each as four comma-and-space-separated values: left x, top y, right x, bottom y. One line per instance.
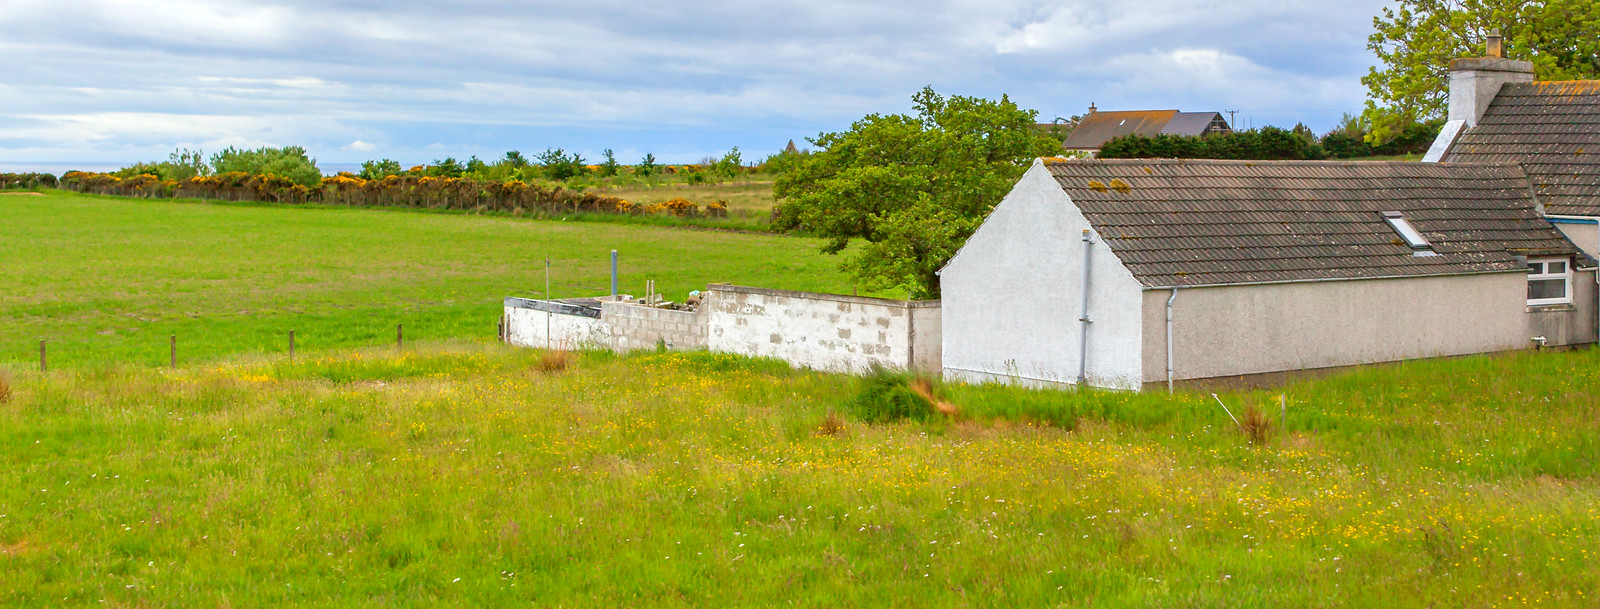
1445, 80, 1600, 216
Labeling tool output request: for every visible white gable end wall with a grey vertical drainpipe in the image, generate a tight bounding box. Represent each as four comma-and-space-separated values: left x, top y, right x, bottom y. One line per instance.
939, 161, 1144, 388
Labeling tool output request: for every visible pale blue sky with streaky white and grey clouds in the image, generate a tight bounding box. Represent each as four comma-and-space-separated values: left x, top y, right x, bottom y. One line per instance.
0, 0, 1386, 168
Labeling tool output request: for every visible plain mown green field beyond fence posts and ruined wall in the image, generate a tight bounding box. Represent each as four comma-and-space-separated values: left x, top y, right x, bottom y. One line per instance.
0, 193, 876, 366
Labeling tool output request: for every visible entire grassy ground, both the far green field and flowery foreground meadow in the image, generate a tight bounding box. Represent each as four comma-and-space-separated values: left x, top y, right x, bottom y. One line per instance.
0, 187, 1600, 607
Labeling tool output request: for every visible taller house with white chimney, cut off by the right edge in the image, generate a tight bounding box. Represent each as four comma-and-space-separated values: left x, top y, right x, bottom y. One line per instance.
1424, 37, 1600, 256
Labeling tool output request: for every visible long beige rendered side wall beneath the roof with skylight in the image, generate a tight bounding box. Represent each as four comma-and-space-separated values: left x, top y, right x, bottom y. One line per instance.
1144, 273, 1531, 382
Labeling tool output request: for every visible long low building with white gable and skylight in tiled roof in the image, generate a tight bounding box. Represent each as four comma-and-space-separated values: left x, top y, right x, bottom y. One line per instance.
941, 160, 1595, 390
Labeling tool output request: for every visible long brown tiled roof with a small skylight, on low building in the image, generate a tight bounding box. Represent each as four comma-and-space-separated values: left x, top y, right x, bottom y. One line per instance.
1045, 160, 1587, 288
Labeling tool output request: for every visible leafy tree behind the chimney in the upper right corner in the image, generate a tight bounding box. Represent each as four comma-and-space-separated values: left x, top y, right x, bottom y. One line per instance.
1362, 0, 1600, 144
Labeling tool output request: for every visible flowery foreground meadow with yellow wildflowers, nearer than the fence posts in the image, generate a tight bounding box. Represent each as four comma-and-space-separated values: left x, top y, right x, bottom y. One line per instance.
0, 342, 1600, 607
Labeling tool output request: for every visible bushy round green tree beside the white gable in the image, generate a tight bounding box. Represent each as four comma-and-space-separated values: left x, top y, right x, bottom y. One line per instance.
773, 88, 1061, 297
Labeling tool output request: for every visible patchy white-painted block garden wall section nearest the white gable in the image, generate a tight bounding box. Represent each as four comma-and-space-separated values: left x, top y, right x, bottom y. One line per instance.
702, 285, 939, 372
